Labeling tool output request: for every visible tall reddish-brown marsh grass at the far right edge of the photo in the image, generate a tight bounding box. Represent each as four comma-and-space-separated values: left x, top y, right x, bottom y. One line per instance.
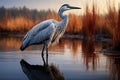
105, 3, 120, 47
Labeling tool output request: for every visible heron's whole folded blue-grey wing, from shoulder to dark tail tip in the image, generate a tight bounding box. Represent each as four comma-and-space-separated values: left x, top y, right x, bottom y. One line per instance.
21, 20, 55, 50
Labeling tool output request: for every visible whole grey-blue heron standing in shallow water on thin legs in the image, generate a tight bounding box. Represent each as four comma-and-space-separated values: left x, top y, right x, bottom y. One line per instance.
20, 4, 81, 65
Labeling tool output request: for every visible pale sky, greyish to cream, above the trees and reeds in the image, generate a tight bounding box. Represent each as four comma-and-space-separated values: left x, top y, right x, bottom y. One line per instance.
0, 0, 120, 14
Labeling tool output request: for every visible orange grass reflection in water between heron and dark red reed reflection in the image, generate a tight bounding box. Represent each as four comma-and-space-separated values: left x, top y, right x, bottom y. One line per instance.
50, 39, 81, 57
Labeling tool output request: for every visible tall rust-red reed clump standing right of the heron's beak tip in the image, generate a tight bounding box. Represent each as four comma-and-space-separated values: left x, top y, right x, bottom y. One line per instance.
82, 4, 97, 39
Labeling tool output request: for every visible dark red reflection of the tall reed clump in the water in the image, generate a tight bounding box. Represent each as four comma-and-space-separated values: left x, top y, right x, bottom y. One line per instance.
82, 40, 99, 70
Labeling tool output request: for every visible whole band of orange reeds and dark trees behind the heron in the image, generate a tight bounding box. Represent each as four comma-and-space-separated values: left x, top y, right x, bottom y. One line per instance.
0, 3, 120, 48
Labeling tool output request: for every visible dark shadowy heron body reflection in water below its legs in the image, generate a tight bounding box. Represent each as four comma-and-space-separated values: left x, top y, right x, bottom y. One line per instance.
20, 59, 64, 80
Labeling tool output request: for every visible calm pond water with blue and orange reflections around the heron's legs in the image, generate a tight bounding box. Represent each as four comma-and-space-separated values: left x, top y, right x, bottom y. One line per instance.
0, 37, 120, 80
